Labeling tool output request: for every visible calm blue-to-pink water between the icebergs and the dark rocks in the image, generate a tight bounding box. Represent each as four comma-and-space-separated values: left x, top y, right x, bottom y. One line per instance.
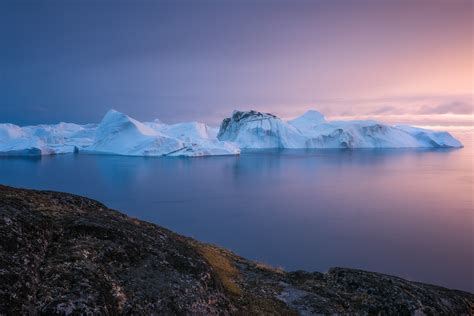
0, 133, 474, 292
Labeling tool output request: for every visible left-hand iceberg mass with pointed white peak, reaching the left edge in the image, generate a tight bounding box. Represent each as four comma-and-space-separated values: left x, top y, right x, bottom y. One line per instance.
0, 110, 240, 157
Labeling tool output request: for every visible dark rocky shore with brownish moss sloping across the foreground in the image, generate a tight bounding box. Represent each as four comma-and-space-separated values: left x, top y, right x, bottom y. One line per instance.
0, 186, 474, 315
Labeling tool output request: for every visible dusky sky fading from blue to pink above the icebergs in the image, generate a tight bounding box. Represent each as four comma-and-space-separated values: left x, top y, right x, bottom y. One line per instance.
0, 0, 474, 127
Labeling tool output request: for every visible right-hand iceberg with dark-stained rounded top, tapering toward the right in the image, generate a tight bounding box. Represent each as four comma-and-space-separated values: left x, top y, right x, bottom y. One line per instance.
218, 111, 462, 149
